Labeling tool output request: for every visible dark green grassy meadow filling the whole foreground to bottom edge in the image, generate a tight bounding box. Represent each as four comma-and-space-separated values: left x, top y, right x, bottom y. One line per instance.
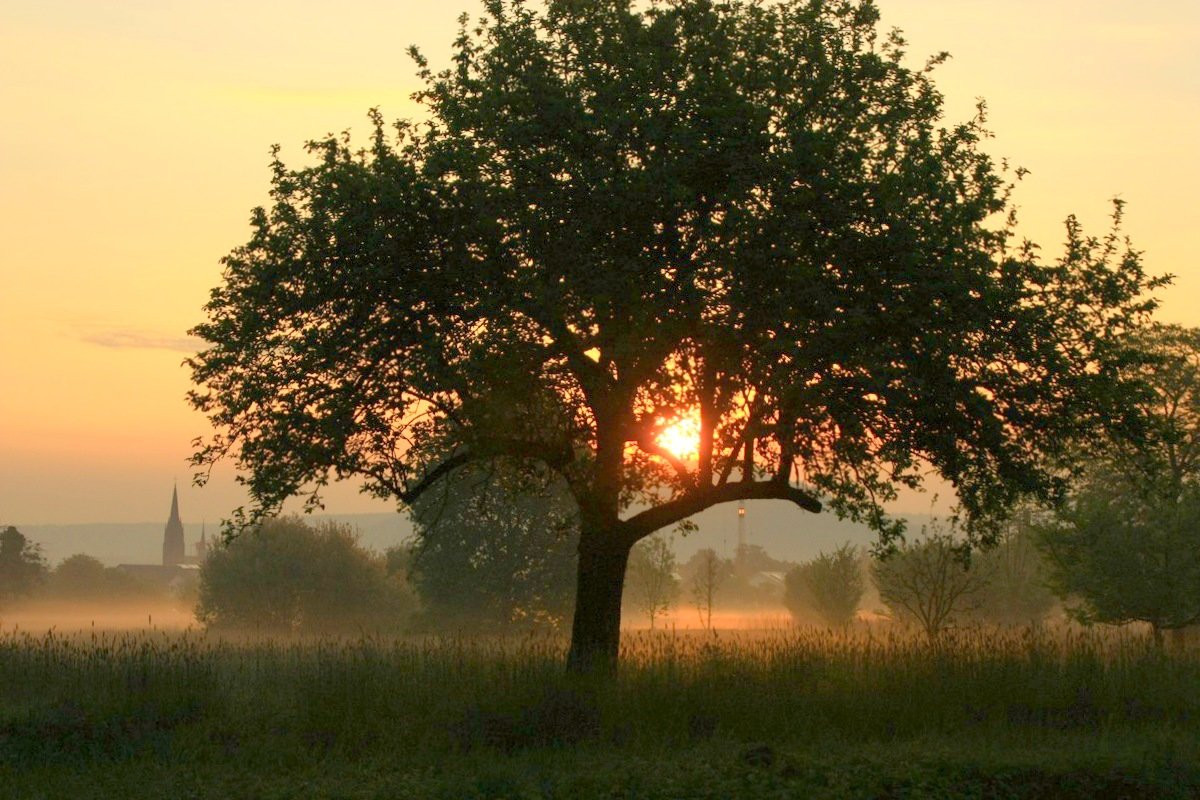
0, 628, 1200, 798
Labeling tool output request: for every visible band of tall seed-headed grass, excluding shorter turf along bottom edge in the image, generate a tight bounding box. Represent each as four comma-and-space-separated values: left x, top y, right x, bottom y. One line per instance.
0, 628, 1200, 763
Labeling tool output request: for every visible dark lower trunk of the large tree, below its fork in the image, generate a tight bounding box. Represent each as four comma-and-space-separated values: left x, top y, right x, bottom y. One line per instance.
566, 529, 630, 675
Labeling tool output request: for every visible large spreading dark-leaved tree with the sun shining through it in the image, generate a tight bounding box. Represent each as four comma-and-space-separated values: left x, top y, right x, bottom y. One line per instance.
191, 0, 1152, 669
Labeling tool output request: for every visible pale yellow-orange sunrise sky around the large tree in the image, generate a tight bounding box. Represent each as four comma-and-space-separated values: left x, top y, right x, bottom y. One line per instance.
0, 0, 1200, 525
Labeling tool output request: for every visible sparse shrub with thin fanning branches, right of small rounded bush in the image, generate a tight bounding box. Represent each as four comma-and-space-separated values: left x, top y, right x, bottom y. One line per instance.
871, 528, 986, 643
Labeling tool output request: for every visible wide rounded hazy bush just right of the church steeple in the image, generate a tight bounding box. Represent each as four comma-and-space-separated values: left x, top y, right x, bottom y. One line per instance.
196, 517, 412, 633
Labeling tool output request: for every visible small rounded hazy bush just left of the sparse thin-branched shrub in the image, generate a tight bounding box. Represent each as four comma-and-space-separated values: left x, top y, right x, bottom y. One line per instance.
784, 542, 866, 627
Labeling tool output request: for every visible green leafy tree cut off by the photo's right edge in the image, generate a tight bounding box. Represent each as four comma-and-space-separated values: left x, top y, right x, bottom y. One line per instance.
1038, 325, 1200, 643
